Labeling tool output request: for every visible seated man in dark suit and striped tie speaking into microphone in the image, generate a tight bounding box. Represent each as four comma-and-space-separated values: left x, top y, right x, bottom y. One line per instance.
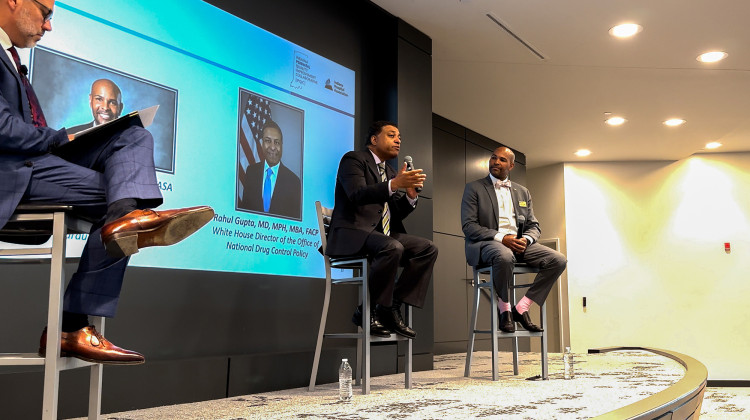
326, 121, 438, 338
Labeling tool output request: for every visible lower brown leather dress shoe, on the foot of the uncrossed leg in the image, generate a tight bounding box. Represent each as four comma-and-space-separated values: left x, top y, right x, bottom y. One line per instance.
39, 325, 146, 365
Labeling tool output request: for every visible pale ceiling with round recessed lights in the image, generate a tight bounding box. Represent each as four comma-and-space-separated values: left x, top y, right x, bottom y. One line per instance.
372, 0, 750, 168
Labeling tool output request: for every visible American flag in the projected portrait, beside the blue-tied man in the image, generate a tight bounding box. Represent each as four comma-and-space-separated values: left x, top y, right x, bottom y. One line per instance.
237, 93, 271, 200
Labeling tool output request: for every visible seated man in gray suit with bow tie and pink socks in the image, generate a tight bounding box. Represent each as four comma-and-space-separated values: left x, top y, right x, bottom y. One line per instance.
461, 147, 567, 332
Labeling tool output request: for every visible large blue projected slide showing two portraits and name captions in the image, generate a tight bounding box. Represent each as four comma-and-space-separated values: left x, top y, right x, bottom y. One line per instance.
22, 0, 355, 277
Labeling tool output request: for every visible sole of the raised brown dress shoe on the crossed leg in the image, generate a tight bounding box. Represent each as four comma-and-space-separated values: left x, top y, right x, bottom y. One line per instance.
105, 208, 214, 258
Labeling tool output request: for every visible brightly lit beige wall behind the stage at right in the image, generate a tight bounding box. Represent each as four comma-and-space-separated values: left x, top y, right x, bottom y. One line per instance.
560, 153, 750, 380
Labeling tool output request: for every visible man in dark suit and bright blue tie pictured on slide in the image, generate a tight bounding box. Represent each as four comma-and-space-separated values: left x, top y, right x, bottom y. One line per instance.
240, 120, 302, 219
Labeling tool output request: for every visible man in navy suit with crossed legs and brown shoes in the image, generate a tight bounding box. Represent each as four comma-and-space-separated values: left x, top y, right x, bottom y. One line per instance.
0, 0, 213, 364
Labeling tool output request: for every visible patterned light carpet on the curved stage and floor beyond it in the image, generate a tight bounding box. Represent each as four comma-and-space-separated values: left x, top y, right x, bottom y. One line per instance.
70, 351, 750, 420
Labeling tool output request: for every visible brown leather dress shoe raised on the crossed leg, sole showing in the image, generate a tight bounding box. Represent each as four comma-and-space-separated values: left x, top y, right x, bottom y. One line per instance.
102, 206, 214, 258
